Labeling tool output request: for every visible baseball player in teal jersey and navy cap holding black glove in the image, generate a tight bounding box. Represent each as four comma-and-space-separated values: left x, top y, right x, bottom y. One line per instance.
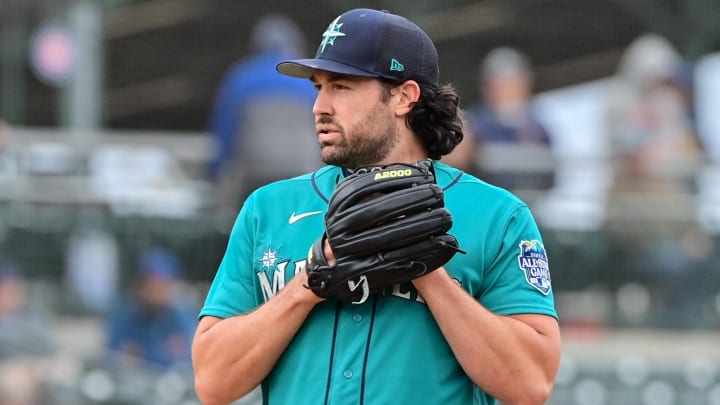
193, 9, 560, 405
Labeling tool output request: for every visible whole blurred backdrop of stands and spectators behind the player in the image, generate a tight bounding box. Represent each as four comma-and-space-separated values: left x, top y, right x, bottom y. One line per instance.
0, 0, 720, 405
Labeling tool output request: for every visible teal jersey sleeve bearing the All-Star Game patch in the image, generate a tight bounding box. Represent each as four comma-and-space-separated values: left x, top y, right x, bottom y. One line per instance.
476, 205, 557, 318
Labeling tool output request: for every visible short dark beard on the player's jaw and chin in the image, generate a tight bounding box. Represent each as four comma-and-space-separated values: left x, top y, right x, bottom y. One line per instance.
319, 106, 400, 169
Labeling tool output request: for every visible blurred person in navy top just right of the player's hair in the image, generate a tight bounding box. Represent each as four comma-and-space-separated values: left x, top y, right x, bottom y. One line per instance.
458, 47, 554, 189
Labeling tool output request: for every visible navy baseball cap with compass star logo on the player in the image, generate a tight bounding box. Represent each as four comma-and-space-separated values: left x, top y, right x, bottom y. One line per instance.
277, 8, 440, 88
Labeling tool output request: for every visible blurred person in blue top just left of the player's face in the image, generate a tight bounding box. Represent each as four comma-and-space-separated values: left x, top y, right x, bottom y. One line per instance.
210, 15, 319, 206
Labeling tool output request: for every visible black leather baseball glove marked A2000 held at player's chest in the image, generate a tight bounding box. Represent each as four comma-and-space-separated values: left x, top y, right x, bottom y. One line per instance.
306, 160, 461, 304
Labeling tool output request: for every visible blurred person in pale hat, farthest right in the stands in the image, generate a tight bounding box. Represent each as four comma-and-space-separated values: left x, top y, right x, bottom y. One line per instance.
608, 34, 702, 192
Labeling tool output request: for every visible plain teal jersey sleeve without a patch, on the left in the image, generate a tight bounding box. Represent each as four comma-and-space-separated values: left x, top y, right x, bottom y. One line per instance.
200, 195, 257, 318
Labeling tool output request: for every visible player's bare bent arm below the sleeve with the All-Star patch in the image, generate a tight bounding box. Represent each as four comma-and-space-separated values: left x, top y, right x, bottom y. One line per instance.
414, 268, 560, 404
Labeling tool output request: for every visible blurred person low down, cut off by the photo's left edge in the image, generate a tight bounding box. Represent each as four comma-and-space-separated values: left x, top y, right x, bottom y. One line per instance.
0, 263, 54, 360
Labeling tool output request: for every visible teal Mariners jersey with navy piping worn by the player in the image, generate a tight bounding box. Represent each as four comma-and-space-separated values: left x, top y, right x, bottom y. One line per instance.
200, 163, 557, 405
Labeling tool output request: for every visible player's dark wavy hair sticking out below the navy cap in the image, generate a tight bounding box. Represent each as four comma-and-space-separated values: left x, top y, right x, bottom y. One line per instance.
382, 81, 464, 160
